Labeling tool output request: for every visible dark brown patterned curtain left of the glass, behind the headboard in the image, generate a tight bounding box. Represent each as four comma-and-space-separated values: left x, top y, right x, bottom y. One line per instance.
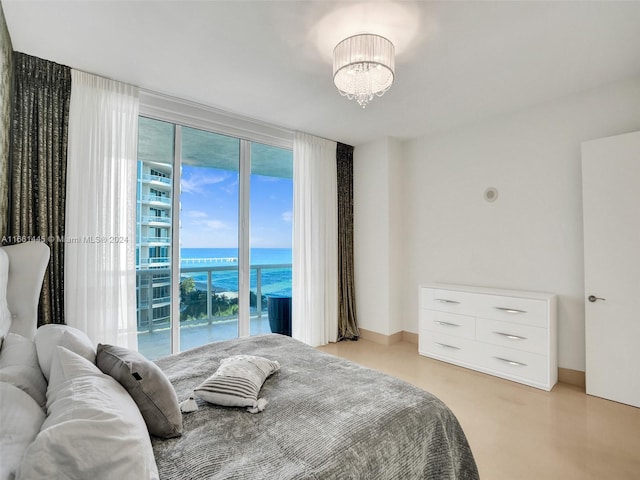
10, 52, 71, 324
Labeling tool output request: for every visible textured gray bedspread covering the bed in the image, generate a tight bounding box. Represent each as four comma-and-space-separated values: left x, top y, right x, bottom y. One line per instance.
152, 335, 478, 480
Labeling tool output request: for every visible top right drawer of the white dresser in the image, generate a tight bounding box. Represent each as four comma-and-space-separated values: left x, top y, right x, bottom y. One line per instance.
475, 295, 549, 327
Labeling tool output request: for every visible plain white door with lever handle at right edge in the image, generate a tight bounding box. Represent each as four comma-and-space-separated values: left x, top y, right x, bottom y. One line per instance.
582, 132, 640, 407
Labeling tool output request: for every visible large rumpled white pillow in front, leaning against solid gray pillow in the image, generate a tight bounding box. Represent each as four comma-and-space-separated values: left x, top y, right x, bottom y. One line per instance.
16, 347, 158, 480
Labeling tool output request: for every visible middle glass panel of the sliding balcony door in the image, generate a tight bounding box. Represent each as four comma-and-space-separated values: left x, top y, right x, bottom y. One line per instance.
180, 127, 240, 350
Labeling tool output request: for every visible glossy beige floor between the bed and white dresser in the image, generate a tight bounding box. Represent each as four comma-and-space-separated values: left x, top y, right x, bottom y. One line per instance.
320, 340, 640, 480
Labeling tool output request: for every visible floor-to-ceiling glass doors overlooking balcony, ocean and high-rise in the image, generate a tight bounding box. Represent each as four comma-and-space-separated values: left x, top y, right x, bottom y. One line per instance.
136, 117, 293, 358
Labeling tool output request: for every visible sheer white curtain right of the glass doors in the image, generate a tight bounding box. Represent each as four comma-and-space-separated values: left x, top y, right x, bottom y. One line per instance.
291, 133, 338, 347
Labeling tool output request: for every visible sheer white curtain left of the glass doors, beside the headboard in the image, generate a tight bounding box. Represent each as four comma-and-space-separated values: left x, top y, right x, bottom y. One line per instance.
64, 70, 138, 349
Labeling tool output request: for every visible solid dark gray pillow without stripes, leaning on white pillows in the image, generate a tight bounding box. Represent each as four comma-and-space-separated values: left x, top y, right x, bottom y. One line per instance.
96, 344, 182, 438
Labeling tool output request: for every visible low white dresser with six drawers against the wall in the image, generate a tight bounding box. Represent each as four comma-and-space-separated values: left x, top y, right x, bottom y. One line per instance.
418, 284, 558, 391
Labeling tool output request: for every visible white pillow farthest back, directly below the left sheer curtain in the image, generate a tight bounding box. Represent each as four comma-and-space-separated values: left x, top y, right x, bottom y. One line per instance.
34, 324, 96, 381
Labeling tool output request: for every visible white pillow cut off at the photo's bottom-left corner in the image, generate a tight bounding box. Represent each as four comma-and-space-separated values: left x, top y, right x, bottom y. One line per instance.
0, 382, 44, 480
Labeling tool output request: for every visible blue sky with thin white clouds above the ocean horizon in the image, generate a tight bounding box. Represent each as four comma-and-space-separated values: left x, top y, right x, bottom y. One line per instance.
180, 164, 293, 248
